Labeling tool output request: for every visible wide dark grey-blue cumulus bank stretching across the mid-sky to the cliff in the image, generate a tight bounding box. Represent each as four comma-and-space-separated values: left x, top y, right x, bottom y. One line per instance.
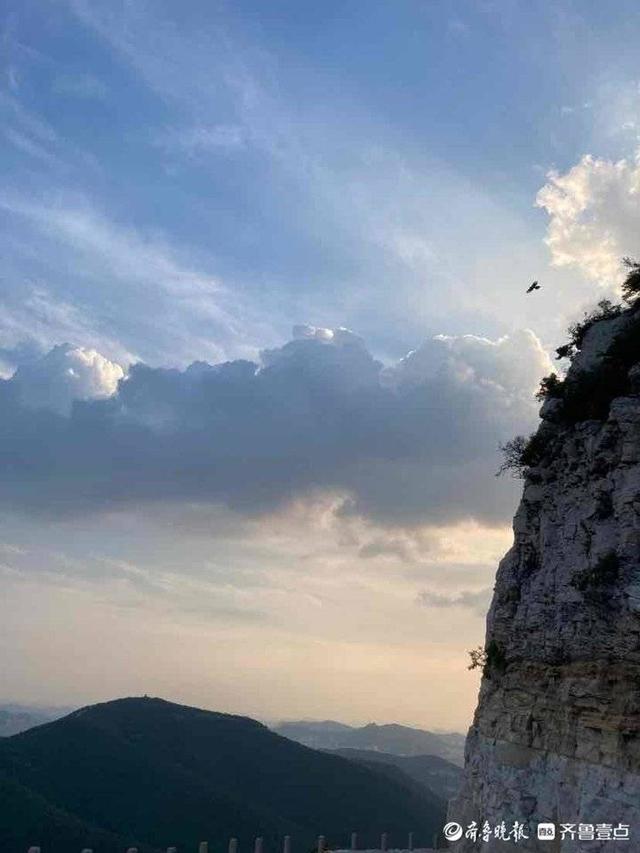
0, 329, 548, 524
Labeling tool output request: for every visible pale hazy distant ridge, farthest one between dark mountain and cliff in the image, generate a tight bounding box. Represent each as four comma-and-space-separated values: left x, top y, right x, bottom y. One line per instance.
274, 720, 465, 766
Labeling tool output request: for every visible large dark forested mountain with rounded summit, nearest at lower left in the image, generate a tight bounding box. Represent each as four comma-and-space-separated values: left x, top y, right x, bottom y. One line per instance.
0, 697, 445, 853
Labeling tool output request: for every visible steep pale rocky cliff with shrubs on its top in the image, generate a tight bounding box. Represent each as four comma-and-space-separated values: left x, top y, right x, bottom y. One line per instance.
449, 302, 640, 853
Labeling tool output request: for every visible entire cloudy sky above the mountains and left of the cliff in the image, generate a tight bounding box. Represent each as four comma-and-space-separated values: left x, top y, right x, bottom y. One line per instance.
0, 0, 640, 730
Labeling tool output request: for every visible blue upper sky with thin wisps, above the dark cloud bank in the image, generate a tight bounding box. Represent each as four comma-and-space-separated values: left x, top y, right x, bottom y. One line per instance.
2, 2, 638, 363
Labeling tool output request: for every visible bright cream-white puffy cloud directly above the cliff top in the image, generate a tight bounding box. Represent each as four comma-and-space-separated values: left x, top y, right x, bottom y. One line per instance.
536, 154, 640, 285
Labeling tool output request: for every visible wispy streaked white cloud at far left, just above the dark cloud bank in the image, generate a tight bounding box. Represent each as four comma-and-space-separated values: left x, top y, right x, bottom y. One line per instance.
0, 192, 273, 364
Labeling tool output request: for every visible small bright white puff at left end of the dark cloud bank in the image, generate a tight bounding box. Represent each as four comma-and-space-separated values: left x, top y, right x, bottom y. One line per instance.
13, 344, 124, 415
